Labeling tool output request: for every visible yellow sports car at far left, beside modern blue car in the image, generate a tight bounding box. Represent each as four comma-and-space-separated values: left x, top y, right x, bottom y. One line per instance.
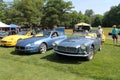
0, 31, 42, 46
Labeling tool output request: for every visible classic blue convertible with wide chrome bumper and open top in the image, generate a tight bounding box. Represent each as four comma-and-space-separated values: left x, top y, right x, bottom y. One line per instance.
53, 32, 101, 60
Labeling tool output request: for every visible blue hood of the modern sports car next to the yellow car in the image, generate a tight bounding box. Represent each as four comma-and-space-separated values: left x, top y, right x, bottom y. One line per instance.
17, 36, 46, 46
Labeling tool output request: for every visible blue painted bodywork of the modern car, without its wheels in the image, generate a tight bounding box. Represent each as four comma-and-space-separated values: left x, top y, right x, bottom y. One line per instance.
15, 28, 67, 53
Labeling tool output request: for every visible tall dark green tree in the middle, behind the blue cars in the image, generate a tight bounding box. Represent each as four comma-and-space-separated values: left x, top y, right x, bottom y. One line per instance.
42, 0, 72, 28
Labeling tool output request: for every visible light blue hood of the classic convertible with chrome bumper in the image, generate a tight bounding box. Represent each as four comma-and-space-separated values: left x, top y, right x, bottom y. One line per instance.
58, 38, 92, 47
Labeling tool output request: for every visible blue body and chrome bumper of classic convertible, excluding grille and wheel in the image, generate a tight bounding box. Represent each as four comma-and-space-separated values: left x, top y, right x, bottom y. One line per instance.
53, 32, 101, 57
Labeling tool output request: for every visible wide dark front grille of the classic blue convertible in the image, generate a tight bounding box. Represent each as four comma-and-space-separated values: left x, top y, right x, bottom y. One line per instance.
57, 46, 78, 53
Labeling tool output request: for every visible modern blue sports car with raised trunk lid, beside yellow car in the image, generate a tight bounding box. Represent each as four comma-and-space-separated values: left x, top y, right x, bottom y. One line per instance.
15, 27, 67, 53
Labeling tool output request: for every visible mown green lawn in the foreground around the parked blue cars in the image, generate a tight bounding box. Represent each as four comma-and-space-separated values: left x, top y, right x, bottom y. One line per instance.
0, 29, 120, 80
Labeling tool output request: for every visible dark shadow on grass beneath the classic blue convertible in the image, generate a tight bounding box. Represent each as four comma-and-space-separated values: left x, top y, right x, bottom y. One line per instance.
40, 53, 86, 64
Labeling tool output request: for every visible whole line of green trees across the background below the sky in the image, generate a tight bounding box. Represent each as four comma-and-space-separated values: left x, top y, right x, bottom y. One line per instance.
0, 0, 120, 28
